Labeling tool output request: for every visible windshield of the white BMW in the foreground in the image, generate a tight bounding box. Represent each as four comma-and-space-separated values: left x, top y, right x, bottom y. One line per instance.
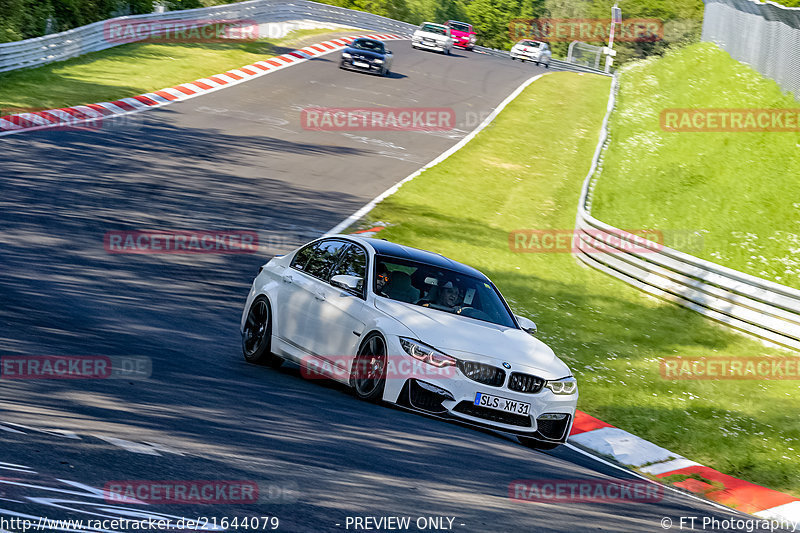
373, 256, 516, 328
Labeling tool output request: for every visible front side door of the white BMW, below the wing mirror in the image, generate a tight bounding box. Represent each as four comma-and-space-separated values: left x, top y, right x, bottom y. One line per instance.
304, 244, 369, 369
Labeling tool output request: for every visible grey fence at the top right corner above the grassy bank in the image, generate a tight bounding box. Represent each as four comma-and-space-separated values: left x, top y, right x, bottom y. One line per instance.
702, 0, 800, 99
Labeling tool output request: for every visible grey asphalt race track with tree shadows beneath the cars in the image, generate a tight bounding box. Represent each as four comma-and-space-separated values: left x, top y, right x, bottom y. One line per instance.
0, 41, 752, 532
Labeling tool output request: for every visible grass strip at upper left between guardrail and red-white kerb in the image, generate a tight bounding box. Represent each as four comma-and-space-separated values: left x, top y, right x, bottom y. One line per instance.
0, 29, 350, 111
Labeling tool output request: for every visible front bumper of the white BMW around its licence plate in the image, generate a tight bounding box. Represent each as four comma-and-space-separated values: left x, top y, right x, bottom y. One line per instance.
385, 339, 578, 436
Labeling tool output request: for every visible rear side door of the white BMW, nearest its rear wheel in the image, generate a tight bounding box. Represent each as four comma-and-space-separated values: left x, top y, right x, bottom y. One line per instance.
277, 239, 347, 353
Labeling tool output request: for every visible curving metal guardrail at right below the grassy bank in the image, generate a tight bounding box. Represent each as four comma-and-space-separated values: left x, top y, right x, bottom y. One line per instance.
575, 77, 800, 350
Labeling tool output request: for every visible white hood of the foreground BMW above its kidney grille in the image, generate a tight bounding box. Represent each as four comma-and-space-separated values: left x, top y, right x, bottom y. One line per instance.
375, 297, 571, 379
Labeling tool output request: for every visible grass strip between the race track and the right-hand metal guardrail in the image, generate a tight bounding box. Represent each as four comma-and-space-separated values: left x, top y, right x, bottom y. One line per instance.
364, 73, 800, 495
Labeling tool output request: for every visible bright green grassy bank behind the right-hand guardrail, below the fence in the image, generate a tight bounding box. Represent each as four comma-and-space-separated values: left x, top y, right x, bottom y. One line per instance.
592, 43, 800, 288
